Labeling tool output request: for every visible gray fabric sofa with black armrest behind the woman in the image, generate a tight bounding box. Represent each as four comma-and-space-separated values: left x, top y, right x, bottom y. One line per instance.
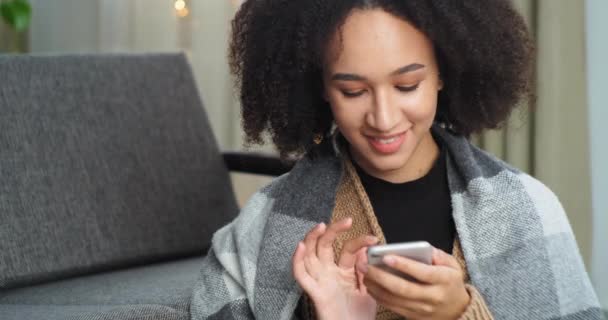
0, 54, 289, 320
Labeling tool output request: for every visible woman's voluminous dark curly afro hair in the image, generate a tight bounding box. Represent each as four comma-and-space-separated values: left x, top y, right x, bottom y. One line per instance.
229, 0, 533, 157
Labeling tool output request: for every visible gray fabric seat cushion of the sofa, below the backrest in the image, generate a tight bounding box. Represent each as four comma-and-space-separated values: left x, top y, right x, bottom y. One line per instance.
0, 257, 202, 320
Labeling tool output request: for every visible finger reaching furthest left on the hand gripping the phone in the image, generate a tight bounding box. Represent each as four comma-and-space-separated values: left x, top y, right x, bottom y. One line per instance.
364, 266, 432, 301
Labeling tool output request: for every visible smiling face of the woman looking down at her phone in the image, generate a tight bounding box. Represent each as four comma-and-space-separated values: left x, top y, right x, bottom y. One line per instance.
323, 9, 442, 182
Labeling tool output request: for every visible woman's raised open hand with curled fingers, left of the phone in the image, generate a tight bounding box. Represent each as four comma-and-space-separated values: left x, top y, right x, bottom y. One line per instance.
292, 218, 378, 320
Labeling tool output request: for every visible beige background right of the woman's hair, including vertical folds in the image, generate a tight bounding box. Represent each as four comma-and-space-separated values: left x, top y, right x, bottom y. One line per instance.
476, 0, 592, 268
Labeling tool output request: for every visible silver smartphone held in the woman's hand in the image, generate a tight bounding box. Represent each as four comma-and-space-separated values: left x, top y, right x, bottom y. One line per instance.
367, 241, 433, 280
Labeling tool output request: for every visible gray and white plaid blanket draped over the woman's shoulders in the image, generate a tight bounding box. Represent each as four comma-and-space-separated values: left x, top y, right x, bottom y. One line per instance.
191, 125, 603, 320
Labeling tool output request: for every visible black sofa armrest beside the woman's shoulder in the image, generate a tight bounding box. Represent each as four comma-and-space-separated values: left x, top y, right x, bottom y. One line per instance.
222, 151, 294, 176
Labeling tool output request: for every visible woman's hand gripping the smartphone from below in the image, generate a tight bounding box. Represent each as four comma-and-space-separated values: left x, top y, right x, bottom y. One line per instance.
358, 249, 470, 320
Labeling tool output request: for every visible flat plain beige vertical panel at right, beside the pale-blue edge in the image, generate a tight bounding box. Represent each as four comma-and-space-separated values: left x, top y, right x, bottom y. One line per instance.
535, 0, 593, 268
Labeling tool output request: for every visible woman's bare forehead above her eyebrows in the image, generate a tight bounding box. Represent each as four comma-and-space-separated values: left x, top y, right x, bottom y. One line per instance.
325, 9, 435, 73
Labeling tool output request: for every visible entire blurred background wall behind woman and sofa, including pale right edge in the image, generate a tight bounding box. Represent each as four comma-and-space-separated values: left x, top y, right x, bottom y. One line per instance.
4, 0, 608, 308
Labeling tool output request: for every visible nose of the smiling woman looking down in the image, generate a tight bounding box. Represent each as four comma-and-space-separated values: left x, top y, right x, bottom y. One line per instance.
366, 91, 401, 132
